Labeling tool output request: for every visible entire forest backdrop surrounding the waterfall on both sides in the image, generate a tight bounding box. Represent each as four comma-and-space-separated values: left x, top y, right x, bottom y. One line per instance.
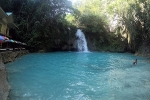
0, 0, 150, 51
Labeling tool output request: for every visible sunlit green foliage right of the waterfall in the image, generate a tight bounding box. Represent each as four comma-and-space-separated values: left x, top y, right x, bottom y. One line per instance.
76, 0, 150, 51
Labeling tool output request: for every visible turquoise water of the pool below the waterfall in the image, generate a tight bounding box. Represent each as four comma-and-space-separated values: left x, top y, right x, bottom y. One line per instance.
6, 52, 150, 100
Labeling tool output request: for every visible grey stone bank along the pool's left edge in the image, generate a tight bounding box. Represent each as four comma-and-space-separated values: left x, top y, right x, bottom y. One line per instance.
0, 50, 29, 100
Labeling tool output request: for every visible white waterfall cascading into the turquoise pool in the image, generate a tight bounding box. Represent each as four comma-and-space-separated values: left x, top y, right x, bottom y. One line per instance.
76, 29, 88, 52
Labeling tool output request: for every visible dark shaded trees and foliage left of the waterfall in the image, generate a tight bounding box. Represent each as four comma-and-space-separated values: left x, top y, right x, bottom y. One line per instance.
0, 0, 73, 51
